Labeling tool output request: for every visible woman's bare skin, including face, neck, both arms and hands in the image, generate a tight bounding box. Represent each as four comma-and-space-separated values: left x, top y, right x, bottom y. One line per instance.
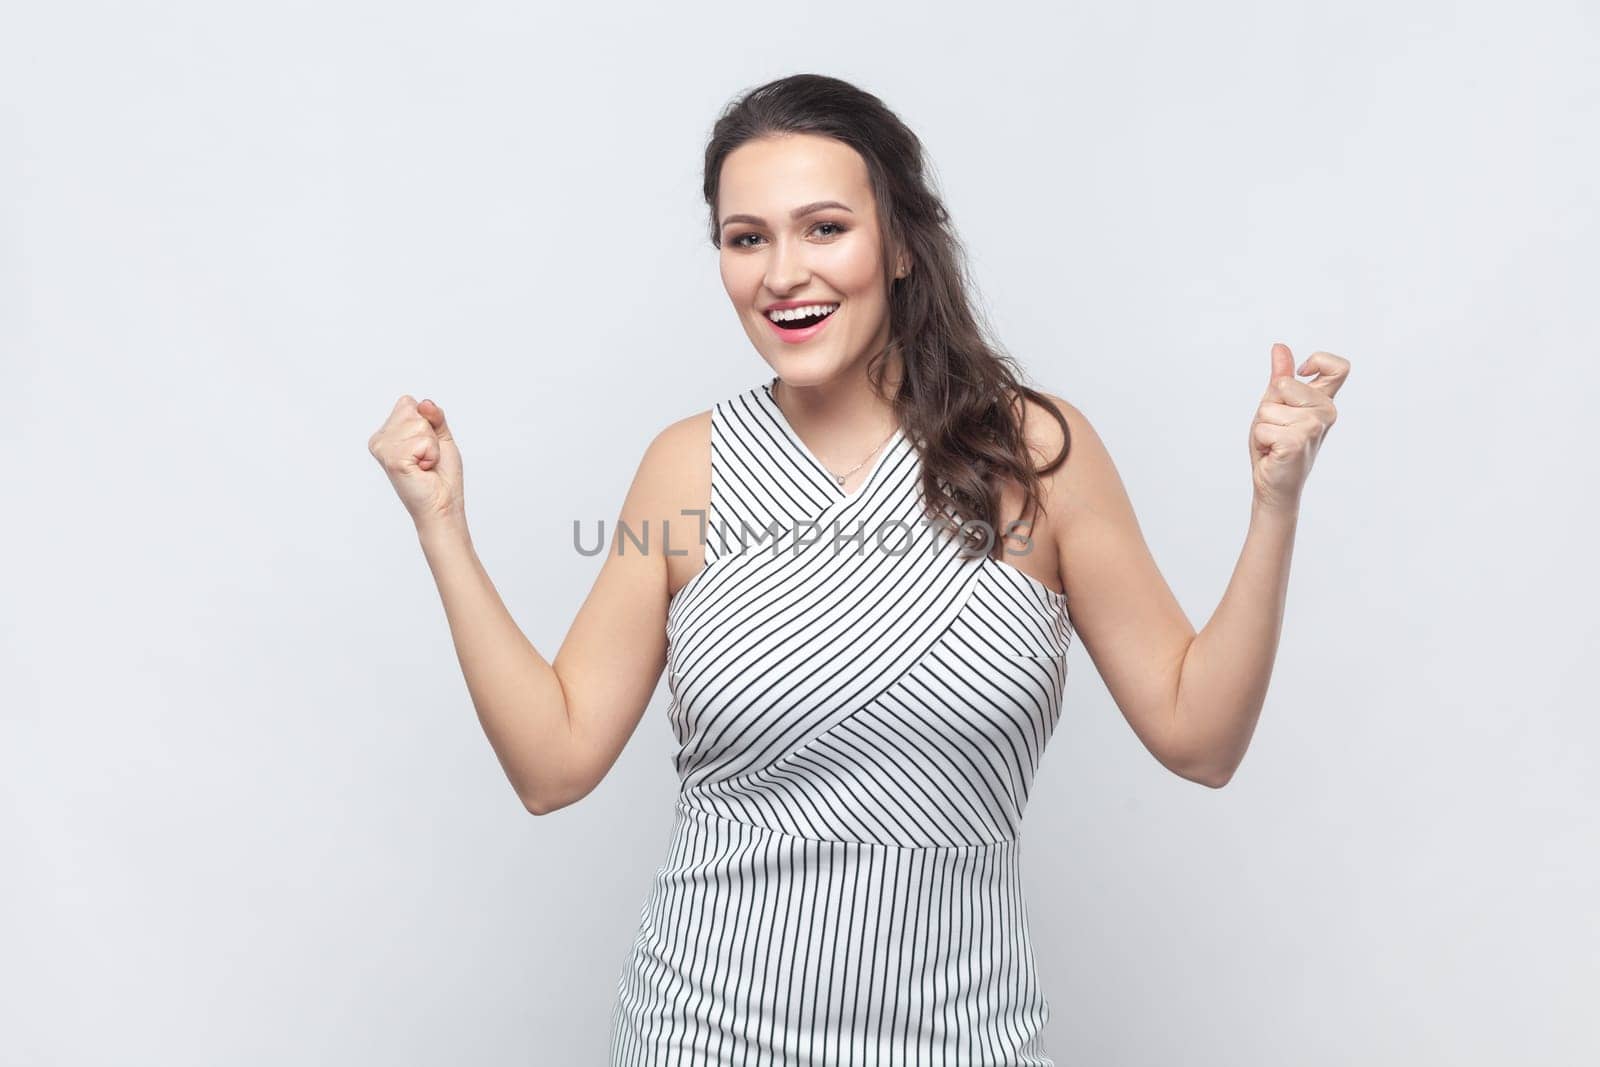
368, 134, 1349, 814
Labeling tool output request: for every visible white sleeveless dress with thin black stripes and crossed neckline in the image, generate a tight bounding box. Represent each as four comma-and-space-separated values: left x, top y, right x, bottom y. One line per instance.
610, 379, 1072, 1067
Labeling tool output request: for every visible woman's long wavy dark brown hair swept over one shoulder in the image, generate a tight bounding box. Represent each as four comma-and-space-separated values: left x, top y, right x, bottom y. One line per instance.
704, 74, 1072, 555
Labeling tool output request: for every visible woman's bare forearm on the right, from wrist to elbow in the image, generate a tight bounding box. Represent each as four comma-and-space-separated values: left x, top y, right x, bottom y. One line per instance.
1173, 504, 1299, 785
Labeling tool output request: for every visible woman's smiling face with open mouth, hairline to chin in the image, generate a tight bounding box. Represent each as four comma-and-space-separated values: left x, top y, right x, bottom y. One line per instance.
717, 134, 890, 386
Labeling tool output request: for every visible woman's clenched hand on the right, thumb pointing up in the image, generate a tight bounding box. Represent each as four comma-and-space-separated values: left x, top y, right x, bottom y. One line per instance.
1250, 344, 1350, 512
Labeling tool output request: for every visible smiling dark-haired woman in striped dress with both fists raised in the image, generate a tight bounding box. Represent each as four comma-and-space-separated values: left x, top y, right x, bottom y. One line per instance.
370, 75, 1349, 1064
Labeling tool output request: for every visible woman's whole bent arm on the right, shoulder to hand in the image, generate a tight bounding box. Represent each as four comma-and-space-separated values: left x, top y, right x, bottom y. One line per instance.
1029, 346, 1349, 787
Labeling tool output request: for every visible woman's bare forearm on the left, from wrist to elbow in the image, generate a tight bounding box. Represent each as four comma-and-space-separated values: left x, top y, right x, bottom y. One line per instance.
418, 522, 571, 806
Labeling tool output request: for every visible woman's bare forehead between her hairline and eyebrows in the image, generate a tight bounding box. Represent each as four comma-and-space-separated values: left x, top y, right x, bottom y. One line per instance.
717, 133, 872, 218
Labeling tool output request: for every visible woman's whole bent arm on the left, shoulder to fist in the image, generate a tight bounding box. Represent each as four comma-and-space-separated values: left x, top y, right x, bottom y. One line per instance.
370, 397, 709, 814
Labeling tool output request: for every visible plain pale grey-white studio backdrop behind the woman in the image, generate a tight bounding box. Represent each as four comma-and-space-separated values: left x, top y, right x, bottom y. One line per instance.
0, 0, 1600, 1067
